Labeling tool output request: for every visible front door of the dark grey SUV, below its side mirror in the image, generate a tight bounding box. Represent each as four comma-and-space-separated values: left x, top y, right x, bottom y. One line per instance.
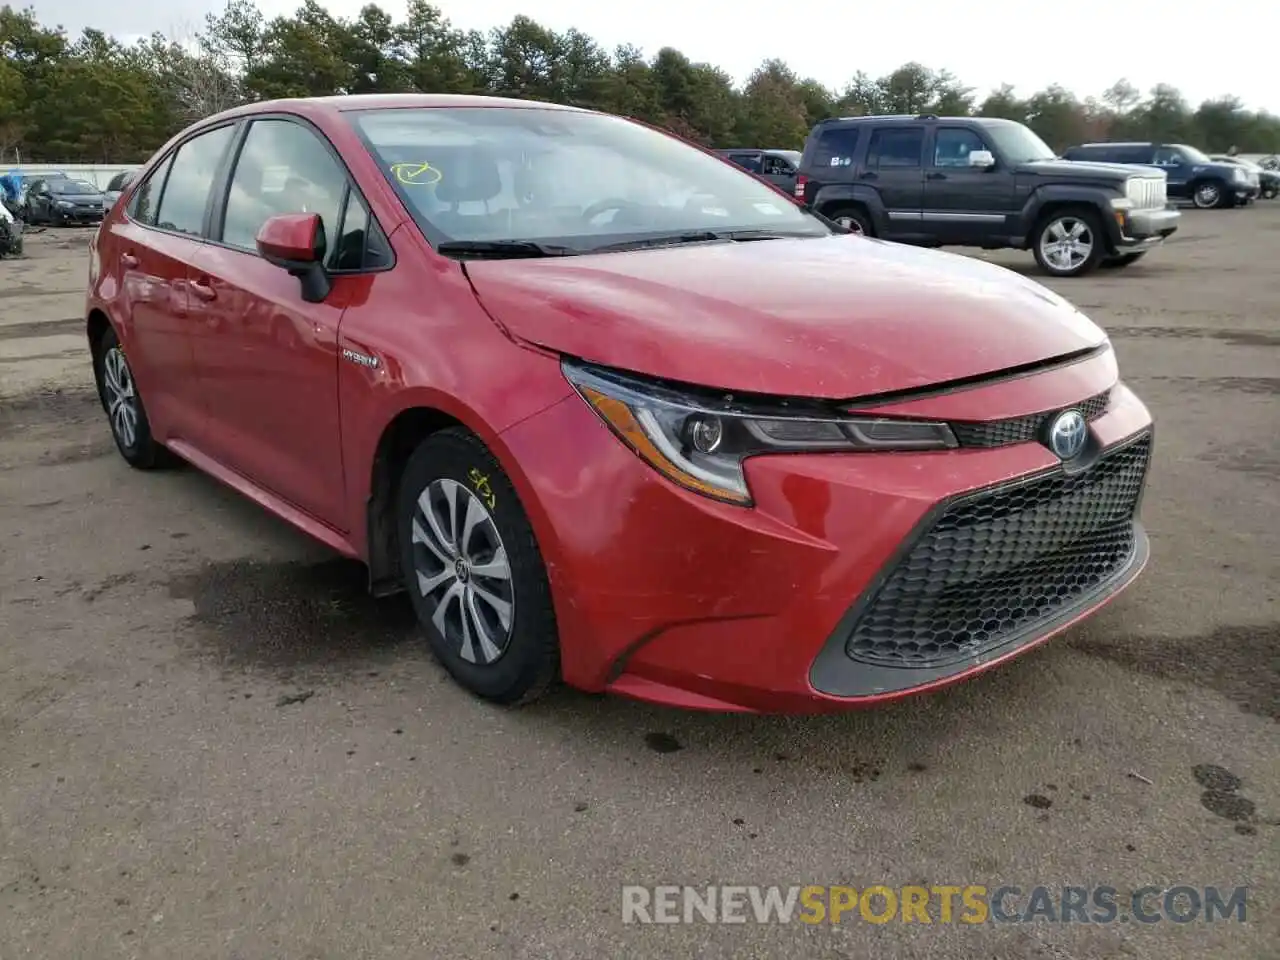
924, 125, 1016, 243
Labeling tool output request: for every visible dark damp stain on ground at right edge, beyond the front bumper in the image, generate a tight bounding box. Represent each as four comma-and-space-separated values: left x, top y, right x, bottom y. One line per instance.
1069, 623, 1280, 721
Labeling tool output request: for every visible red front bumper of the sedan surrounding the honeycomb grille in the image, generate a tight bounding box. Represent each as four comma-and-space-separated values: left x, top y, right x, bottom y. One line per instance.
502, 360, 1151, 713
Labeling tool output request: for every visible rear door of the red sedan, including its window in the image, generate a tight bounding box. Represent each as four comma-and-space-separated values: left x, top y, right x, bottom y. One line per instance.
110, 124, 236, 440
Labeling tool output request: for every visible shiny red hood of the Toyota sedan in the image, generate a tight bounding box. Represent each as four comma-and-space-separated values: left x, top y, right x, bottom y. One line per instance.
466, 236, 1106, 399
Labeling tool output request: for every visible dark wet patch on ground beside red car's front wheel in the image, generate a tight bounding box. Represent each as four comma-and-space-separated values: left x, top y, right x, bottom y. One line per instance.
169, 558, 430, 678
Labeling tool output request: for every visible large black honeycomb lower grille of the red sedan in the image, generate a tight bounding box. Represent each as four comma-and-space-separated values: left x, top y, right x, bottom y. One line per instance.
845, 434, 1151, 667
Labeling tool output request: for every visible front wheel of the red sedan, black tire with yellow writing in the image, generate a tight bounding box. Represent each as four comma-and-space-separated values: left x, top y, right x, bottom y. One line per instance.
396, 428, 559, 707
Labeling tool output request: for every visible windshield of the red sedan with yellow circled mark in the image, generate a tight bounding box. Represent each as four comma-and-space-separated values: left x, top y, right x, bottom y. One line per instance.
355, 108, 831, 251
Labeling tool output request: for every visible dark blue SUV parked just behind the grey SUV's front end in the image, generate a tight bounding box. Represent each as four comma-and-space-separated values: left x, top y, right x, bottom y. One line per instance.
1062, 143, 1260, 210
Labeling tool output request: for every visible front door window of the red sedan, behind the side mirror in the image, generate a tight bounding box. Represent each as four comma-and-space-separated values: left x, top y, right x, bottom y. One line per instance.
221, 120, 347, 256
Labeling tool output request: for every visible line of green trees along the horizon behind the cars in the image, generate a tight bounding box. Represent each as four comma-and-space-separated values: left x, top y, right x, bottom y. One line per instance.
0, 0, 1280, 163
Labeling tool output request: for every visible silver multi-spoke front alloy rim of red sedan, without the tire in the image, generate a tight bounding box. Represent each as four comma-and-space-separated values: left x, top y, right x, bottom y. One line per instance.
412, 479, 516, 666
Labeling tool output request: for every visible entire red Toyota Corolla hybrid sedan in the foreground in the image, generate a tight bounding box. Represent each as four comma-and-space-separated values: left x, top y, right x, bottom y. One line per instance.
87, 96, 1152, 712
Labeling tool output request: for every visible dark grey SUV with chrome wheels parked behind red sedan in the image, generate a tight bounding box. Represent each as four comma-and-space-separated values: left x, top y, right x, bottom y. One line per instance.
795, 115, 1180, 276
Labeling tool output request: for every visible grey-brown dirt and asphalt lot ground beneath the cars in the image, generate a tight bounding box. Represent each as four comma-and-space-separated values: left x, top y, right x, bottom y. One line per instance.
0, 212, 1280, 960
